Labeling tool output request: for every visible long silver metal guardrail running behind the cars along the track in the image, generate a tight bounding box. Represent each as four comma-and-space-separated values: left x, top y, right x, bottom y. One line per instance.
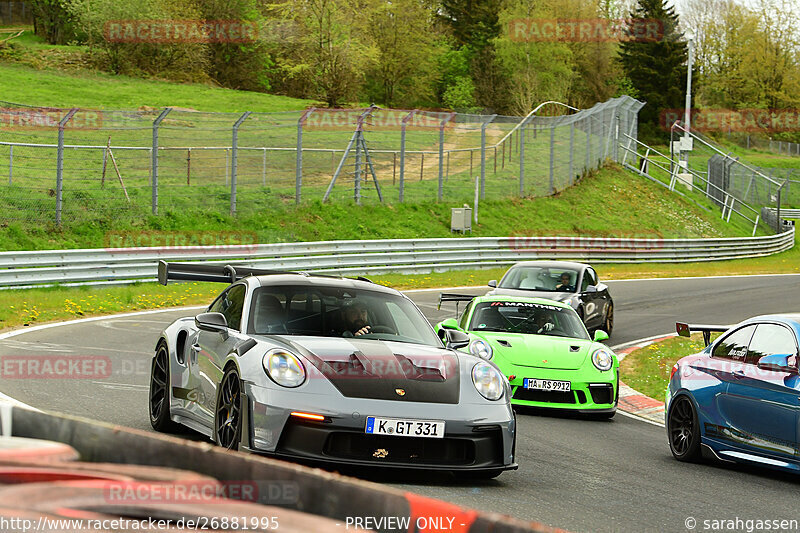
0, 228, 794, 288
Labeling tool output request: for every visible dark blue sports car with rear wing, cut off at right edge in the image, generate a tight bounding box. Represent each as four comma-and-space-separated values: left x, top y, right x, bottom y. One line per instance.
665, 314, 800, 472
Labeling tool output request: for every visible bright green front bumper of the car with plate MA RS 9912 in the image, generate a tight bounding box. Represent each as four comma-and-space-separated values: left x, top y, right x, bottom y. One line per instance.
510, 366, 619, 414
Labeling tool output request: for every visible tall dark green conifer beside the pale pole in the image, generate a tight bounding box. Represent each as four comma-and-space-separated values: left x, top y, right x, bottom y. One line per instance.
619, 0, 687, 136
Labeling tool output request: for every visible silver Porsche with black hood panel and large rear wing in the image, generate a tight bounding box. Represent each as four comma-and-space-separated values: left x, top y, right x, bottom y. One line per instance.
149, 261, 517, 477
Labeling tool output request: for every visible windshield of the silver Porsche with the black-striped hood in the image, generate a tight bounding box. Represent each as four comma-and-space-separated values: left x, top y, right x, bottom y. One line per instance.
248, 286, 442, 347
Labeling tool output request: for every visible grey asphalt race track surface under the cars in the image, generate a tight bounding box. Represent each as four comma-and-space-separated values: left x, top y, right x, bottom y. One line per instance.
0, 275, 800, 531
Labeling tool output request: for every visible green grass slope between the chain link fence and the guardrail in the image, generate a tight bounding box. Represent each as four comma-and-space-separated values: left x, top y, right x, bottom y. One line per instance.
0, 162, 750, 250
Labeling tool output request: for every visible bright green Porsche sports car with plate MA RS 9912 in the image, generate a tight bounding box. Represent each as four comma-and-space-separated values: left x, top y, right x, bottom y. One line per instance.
436, 294, 619, 418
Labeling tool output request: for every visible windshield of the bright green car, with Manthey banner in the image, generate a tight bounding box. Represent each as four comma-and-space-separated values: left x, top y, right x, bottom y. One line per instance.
469, 301, 589, 339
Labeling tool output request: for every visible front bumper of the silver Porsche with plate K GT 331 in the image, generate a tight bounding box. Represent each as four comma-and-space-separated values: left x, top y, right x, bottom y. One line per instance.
243, 384, 517, 472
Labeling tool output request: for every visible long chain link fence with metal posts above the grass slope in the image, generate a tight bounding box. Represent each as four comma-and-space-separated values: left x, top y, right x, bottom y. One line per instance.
0, 96, 644, 225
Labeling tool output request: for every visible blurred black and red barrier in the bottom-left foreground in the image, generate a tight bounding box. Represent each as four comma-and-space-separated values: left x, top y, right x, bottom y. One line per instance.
7, 407, 561, 533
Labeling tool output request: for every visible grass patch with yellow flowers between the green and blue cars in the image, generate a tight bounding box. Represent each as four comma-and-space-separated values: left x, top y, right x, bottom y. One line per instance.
620, 333, 719, 401
